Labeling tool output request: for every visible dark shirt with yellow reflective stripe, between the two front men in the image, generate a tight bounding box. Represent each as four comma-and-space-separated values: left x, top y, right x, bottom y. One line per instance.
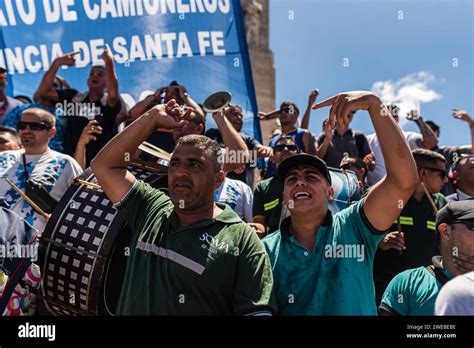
253, 176, 283, 233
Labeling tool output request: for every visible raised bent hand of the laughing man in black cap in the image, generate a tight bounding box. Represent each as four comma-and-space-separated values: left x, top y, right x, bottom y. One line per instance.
313, 91, 382, 127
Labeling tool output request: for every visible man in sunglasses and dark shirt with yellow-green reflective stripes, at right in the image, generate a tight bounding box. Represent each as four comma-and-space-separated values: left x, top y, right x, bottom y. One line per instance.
374, 149, 447, 304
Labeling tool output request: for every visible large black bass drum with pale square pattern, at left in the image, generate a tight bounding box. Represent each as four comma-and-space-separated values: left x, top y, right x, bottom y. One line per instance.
39, 163, 167, 315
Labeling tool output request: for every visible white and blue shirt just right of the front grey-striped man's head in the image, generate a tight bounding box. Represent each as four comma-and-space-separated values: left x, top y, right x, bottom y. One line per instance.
214, 177, 253, 222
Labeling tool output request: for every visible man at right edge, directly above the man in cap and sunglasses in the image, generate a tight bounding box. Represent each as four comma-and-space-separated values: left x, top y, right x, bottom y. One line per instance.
446, 154, 474, 201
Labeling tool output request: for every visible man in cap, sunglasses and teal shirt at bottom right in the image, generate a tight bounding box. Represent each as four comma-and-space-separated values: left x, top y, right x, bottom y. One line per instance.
379, 200, 474, 315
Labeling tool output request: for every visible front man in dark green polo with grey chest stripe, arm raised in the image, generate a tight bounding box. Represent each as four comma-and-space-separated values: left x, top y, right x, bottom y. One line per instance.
92, 100, 274, 315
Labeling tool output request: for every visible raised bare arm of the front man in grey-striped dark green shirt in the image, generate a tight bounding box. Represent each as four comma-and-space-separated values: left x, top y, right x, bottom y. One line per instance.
91, 99, 186, 203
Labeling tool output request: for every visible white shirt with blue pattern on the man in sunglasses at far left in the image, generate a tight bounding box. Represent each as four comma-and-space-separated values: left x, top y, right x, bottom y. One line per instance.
0, 149, 82, 234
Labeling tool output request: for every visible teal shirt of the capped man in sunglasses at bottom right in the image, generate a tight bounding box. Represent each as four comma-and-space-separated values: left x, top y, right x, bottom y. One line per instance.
380, 257, 453, 315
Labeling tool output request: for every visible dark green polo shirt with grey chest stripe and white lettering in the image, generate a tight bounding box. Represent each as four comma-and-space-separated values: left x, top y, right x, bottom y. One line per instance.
116, 180, 274, 315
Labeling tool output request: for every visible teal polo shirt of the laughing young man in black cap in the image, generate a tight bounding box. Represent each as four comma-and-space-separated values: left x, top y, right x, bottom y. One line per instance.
263, 201, 384, 315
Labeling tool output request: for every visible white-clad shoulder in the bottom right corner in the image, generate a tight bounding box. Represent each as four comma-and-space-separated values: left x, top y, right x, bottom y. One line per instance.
435, 272, 474, 315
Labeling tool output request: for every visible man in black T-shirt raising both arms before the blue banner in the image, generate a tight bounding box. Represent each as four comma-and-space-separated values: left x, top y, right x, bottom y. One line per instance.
37, 48, 122, 167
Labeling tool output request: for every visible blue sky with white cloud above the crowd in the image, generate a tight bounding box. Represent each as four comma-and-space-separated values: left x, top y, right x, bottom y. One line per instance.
270, 0, 474, 145
